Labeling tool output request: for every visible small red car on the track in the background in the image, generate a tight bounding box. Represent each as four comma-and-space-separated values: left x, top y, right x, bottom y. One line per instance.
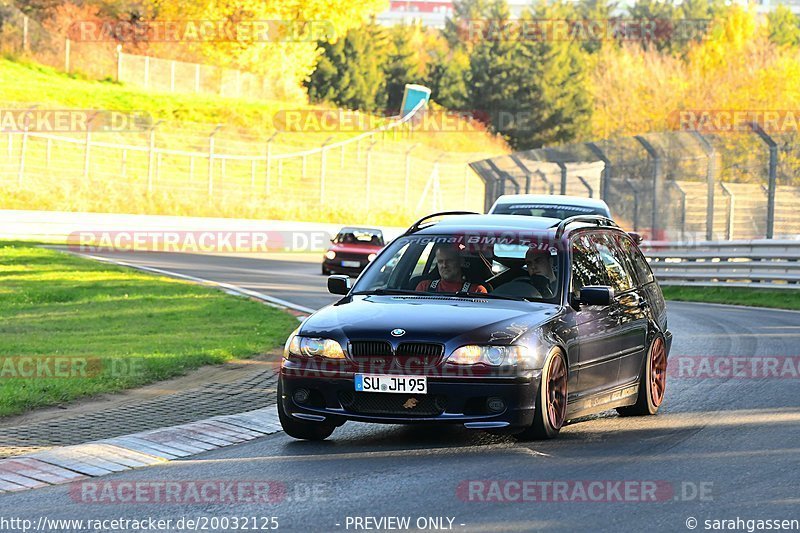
322, 227, 385, 276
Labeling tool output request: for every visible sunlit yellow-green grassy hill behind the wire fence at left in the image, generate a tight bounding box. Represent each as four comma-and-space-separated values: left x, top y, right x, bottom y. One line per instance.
0, 58, 508, 225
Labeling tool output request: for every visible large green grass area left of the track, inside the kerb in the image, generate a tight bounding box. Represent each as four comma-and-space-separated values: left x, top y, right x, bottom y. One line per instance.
0, 242, 297, 416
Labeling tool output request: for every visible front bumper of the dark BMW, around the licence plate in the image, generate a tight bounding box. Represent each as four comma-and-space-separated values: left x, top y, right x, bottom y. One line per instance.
278, 366, 541, 430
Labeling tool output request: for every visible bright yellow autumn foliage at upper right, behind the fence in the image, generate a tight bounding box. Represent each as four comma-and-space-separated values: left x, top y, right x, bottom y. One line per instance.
590, 6, 800, 138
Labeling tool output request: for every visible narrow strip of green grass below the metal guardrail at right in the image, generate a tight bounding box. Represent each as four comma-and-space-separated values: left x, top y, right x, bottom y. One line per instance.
661, 286, 800, 310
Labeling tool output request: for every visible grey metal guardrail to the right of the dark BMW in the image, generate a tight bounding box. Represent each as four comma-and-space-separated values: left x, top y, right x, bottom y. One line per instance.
642, 239, 800, 289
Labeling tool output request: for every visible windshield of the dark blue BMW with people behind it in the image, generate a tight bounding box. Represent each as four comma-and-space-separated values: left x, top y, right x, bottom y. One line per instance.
354, 233, 563, 303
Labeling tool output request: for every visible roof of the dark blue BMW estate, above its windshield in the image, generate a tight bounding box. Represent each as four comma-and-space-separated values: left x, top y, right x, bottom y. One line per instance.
414, 214, 622, 238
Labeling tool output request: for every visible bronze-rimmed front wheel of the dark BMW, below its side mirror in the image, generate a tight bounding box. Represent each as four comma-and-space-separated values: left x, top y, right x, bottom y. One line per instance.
515, 350, 569, 440
